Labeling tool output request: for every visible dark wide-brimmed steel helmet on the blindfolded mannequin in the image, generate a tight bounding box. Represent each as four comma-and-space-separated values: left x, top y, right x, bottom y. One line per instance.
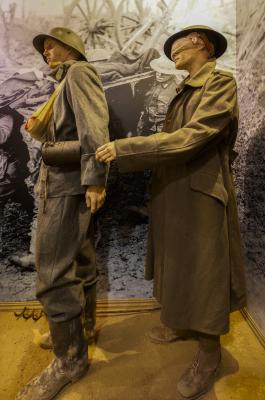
164, 25, 227, 60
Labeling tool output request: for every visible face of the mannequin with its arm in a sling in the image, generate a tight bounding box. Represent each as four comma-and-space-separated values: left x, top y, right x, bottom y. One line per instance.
43, 38, 71, 68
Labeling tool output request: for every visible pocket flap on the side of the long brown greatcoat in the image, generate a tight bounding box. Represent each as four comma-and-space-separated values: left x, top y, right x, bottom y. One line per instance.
190, 171, 228, 206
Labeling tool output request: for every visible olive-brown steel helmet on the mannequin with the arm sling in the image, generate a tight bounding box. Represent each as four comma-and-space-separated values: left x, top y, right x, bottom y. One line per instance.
33, 26, 87, 62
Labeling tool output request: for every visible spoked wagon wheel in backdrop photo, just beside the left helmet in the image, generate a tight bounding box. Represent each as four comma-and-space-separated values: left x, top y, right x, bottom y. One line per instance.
64, 0, 117, 49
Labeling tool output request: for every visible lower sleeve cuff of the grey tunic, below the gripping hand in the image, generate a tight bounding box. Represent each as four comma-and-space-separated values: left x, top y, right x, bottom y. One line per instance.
81, 154, 108, 186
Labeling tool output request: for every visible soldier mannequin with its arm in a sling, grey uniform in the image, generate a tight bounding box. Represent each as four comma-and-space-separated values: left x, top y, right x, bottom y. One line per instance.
16, 27, 109, 400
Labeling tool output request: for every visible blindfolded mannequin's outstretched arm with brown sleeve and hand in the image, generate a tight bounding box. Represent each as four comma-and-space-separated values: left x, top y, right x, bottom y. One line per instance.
97, 74, 237, 171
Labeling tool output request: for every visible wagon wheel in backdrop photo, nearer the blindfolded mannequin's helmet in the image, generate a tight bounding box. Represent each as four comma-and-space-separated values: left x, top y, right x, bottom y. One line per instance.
115, 0, 178, 59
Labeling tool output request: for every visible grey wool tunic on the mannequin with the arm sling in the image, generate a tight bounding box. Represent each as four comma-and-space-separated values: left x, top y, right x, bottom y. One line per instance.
38, 60, 109, 197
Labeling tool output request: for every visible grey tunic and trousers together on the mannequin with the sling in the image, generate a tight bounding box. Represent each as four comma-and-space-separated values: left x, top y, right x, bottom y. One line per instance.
36, 60, 109, 323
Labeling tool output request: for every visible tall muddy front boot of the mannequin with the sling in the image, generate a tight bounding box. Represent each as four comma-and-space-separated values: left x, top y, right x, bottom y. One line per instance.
15, 317, 88, 400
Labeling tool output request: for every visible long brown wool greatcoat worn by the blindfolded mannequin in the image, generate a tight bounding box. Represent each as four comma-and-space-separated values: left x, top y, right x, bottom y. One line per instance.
115, 59, 245, 335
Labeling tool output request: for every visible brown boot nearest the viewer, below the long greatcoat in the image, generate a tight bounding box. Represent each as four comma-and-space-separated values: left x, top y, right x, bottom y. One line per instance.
177, 335, 221, 400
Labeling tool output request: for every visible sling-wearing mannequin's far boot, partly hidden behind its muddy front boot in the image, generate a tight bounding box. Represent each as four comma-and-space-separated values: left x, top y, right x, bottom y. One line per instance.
39, 285, 96, 350
